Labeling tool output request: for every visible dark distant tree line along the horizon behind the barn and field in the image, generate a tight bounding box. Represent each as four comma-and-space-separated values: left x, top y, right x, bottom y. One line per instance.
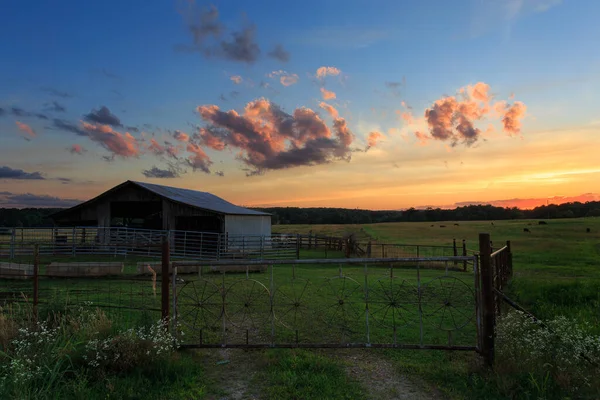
0, 201, 600, 227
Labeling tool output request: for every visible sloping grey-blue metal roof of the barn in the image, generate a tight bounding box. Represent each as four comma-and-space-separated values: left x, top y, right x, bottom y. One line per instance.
129, 181, 270, 215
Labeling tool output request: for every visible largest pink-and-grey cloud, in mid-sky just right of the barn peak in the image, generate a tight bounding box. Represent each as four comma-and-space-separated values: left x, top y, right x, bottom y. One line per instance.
195, 99, 354, 175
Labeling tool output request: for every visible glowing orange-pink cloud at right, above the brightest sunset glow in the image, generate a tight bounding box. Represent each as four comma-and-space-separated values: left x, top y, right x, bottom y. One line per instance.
425, 82, 526, 146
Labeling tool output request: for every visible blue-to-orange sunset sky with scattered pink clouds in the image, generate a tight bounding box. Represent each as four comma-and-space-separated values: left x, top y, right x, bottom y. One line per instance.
0, 0, 600, 209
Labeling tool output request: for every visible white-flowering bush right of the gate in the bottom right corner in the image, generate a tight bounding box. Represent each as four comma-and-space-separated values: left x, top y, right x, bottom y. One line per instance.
495, 311, 600, 398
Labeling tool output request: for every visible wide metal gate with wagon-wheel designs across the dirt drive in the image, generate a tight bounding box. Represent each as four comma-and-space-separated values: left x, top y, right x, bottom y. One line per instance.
173, 256, 481, 350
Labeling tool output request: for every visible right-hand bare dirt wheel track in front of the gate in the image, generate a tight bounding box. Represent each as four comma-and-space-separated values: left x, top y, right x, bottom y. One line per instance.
331, 349, 444, 400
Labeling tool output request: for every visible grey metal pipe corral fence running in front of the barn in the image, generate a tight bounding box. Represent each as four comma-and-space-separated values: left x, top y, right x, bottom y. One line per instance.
0, 227, 299, 260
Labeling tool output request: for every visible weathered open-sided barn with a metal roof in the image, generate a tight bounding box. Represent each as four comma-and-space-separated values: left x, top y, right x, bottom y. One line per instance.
52, 181, 271, 236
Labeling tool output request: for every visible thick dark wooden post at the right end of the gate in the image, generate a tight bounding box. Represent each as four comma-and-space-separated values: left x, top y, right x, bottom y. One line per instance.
479, 233, 496, 367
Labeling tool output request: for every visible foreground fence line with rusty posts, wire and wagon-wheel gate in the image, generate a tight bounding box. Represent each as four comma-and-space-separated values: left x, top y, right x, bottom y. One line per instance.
0, 234, 512, 364
